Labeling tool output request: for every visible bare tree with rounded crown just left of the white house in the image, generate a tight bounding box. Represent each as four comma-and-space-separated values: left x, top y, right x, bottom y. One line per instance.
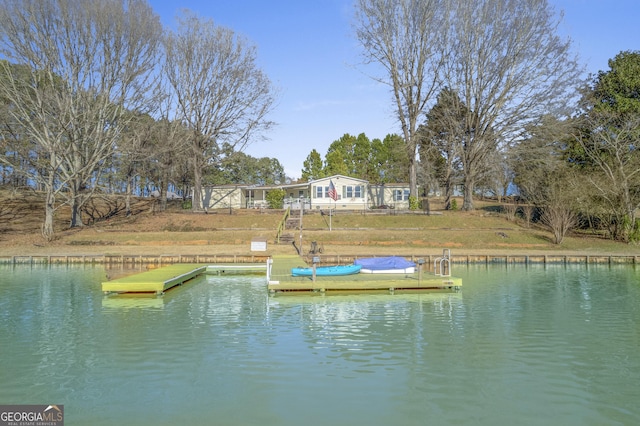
165, 12, 275, 211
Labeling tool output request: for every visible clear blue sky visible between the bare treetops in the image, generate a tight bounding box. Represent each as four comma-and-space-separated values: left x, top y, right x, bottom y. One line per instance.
149, 0, 640, 178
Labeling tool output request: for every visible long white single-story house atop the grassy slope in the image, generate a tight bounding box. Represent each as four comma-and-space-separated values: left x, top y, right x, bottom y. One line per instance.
202, 175, 409, 211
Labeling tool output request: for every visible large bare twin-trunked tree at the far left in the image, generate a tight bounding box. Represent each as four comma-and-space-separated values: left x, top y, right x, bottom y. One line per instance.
0, 0, 162, 238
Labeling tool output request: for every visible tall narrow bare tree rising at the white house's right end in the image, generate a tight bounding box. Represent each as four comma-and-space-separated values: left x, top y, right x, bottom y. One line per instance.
355, 0, 448, 197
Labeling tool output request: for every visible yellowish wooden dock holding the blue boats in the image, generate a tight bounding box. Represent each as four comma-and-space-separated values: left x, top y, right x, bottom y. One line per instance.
267, 256, 462, 293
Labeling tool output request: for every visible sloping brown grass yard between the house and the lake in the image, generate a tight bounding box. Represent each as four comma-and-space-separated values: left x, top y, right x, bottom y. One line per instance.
0, 192, 640, 256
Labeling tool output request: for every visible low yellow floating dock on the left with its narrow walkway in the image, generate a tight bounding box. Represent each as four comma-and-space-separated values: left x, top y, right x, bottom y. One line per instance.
102, 263, 267, 294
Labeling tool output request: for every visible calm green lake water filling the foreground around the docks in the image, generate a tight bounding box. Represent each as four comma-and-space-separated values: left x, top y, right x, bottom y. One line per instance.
0, 265, 640, 426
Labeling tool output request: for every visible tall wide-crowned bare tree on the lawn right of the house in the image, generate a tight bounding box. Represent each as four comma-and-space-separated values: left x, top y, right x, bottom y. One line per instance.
444, 0, 581, 210
